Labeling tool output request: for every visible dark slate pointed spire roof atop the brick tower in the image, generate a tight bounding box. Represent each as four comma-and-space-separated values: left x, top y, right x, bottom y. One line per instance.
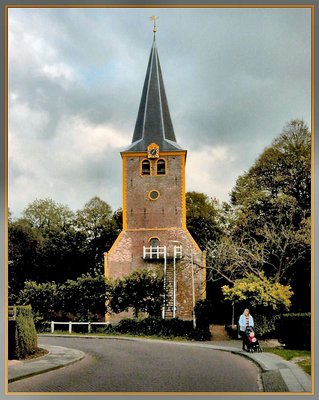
126, 35, 181, 151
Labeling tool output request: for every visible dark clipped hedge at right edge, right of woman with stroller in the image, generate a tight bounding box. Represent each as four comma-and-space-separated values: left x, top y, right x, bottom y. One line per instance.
276, 313, 311, 350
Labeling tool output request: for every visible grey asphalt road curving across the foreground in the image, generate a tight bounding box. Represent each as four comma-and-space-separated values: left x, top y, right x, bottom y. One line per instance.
8, 337, 260, 393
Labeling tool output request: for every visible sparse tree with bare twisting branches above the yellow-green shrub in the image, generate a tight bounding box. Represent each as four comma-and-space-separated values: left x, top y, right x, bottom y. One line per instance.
207, 220, 310, 283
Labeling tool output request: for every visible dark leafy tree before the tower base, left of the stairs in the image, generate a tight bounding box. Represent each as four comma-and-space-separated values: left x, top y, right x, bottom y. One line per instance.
109, 270, 164, 318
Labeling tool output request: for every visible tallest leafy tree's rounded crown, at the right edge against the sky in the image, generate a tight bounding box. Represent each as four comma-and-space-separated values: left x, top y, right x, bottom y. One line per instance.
231, 120, 311, 232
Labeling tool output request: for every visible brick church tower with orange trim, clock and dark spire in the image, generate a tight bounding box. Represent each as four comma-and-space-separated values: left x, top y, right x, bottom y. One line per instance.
104, 34, 206, 321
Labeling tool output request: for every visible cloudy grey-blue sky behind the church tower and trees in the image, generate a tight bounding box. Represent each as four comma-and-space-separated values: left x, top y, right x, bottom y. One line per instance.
8, 8, 311, 216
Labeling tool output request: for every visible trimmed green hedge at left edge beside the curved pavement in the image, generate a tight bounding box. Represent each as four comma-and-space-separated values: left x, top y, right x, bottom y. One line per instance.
9, 306, 38, 359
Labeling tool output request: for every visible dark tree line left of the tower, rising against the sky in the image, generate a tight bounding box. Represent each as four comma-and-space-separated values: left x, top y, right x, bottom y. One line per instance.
8, 197, 121, 304
